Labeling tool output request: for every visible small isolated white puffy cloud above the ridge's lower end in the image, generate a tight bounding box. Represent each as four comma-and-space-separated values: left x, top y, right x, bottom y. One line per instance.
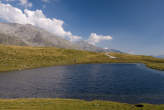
88, 33, 112, 45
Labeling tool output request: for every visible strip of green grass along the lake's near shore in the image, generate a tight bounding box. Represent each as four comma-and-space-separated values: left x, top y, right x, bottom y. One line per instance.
0, 99, 164, 110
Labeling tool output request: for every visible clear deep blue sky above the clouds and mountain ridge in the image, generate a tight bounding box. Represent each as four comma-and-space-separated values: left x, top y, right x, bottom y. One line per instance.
0, 0, 164, 55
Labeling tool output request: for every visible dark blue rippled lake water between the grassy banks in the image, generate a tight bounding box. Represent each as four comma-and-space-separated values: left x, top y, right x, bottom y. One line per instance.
0, 64, 164, 104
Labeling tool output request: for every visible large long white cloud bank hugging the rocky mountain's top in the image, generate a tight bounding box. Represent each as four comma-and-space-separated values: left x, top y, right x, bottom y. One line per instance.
0, 3, 81, 41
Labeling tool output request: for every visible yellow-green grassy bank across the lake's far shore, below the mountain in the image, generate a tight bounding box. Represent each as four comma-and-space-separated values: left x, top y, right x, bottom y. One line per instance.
0, 45, 164, 72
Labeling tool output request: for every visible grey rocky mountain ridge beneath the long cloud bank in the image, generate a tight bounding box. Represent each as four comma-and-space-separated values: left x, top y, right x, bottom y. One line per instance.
0, 23, 120, 52
